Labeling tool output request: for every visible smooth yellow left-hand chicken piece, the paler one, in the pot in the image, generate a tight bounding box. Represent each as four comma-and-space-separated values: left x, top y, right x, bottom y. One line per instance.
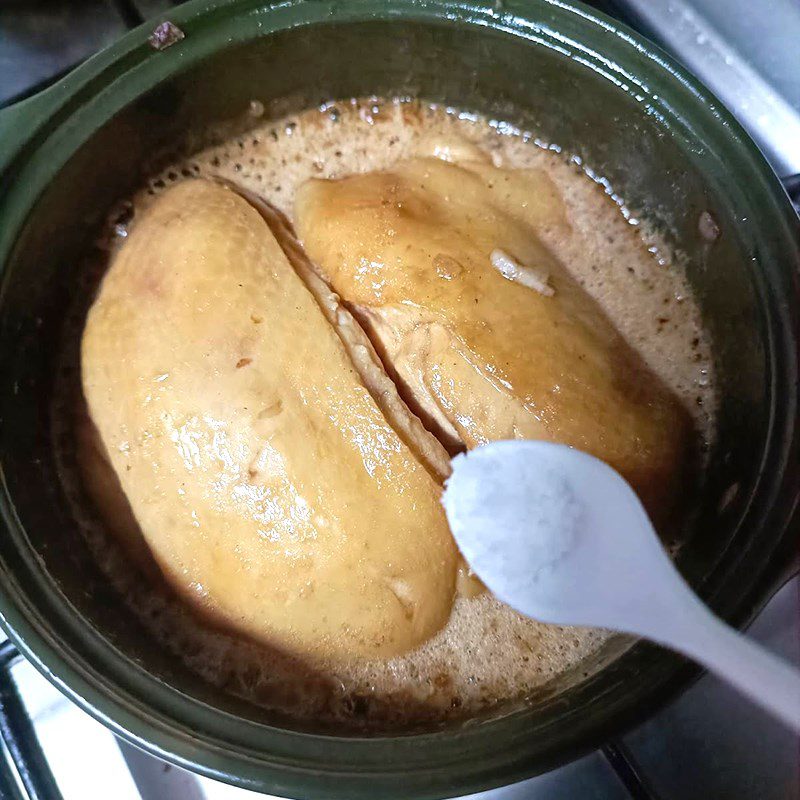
82, 180, 458, 660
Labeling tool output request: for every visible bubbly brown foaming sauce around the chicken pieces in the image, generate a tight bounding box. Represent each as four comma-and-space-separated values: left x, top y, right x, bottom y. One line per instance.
54, 99, 715, 730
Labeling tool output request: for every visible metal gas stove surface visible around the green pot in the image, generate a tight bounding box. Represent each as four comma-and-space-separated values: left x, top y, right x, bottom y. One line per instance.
0, 0, 800, 800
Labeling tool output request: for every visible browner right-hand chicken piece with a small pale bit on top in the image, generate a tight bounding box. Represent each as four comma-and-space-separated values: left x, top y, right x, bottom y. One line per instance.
295, 143, 690, 519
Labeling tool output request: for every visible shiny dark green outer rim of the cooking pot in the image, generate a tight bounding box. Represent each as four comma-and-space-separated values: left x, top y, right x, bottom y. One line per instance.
0, 0, 800, 799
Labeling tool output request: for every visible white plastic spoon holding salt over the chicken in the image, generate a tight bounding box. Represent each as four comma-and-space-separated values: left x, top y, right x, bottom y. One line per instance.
442, 441, 800, 732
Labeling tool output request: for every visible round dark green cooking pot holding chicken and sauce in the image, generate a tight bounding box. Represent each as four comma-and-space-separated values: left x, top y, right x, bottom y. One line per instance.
0, 0, 800, 800
